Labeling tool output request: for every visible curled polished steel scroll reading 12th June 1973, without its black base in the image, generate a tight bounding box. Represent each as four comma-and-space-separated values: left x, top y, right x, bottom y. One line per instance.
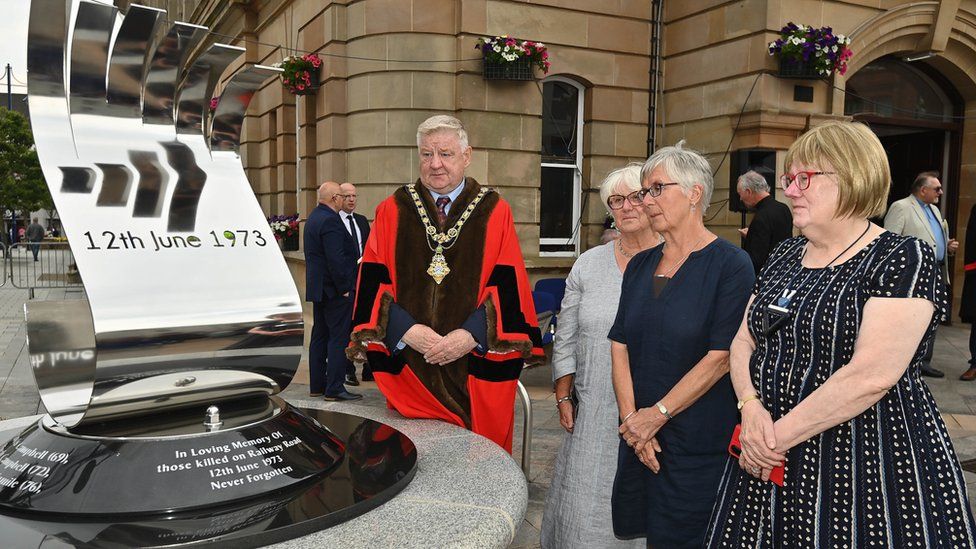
27, 0, 303, 427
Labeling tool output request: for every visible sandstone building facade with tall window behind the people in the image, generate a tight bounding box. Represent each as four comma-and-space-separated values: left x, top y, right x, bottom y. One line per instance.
133, 0, 976, 308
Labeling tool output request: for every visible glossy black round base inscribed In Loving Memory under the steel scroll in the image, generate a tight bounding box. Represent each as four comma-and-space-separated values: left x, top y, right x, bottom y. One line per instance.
0, 403, 417, 548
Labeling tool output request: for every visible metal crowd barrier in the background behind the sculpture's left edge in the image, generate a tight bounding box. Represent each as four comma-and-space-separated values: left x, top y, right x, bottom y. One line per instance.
9, 242, 82, 299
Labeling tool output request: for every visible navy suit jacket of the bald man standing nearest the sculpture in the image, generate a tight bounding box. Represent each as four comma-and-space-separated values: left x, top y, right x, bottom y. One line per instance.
305, 204, 359, 302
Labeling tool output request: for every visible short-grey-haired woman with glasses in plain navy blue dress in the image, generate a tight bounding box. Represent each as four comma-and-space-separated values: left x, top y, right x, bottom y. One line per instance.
609, 139, 754, 549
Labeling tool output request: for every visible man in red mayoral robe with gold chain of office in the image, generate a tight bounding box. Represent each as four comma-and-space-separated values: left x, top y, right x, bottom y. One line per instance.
348, 115, 544, 452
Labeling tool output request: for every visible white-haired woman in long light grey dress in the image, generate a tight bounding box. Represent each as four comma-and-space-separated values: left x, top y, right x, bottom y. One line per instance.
542, 164, 660, 548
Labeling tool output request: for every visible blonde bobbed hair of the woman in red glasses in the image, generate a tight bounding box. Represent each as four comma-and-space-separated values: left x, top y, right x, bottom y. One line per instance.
784, 121, 891, 218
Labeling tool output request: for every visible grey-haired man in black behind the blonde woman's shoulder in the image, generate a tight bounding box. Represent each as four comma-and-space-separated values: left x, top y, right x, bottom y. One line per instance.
736, 170, 793, 274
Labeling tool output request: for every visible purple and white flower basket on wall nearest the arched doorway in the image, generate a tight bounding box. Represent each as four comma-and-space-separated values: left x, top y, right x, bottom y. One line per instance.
769, 22, 853, 79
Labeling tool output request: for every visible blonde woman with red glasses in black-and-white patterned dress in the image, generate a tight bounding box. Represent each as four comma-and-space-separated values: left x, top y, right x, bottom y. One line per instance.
706, 122, 976, 549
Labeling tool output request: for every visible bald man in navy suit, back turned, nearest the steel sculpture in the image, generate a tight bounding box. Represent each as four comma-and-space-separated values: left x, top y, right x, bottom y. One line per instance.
305, 181, 363, 400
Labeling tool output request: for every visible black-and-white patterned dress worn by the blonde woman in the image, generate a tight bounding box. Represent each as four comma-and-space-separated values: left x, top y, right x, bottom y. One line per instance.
706, 232, 976, 549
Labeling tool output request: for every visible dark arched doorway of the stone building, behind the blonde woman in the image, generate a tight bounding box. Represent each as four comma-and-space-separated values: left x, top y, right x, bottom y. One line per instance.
844, 56, 964, 227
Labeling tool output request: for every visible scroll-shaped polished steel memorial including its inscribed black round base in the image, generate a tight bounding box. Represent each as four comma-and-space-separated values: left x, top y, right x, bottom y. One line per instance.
0, 0, 416, 547
